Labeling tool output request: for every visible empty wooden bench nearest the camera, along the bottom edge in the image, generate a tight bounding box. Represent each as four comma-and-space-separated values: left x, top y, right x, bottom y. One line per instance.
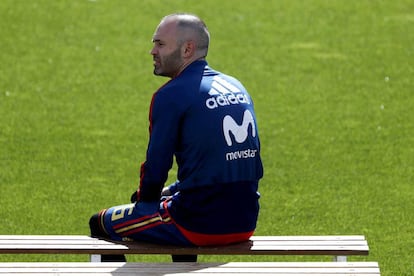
0, 262, 380, 276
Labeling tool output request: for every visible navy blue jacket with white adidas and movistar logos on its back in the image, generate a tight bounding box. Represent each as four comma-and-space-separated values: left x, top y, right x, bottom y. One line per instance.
138, 61, 263, 245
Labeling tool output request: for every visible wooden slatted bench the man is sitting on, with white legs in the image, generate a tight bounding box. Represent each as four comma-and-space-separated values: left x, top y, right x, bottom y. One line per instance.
0, 235, 369, 262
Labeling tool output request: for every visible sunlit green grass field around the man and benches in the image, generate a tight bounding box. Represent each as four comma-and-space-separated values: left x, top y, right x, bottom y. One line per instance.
0, 0, 414, 275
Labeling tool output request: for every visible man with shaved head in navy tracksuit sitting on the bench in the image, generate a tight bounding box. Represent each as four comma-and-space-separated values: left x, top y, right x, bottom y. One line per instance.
89, 14, 263, 261
